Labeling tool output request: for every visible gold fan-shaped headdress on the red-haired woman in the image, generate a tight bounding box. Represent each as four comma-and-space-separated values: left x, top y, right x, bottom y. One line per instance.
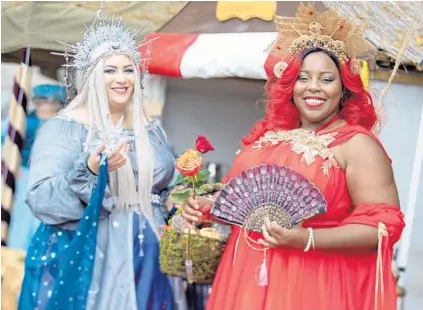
270, 3, 371, 77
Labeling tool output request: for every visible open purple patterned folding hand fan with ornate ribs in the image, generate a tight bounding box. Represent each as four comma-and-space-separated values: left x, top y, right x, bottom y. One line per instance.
211, 164, 327, 232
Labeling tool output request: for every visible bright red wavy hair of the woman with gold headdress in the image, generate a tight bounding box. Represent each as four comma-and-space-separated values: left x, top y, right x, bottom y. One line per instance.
241, 48, 378, 145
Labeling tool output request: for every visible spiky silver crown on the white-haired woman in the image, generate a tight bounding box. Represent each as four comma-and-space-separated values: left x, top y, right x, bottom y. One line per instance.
68, 19, 141, 71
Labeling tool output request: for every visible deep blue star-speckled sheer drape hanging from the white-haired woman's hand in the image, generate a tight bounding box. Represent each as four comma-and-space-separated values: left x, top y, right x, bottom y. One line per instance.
18, 160, 108, 310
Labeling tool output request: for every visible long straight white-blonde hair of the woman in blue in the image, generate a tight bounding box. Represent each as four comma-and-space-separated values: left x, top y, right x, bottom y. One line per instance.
61, 53, 154, 230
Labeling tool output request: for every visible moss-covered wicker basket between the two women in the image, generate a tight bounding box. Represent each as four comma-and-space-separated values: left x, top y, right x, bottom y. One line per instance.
160, 227, 226, 284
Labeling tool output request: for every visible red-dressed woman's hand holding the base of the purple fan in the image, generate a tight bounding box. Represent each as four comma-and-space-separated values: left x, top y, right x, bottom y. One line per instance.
258, 219, 308, 249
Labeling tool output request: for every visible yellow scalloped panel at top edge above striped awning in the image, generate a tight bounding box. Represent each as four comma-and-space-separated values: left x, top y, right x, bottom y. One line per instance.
216, 1, 277, 22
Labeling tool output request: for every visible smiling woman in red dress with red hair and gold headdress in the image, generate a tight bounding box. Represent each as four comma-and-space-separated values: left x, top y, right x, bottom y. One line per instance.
183, 7, 404, 310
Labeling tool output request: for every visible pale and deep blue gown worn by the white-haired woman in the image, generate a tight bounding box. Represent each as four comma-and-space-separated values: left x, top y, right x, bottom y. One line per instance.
19, 117, 186, 310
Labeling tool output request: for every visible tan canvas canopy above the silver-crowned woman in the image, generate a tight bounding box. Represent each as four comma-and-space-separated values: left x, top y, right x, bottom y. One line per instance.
1, 1, 188, 53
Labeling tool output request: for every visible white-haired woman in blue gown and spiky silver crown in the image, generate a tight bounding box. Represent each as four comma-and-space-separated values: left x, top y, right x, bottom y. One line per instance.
19, 6, 187, 310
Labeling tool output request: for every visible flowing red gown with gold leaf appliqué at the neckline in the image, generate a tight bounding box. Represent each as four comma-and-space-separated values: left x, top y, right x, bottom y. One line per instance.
206, 125, 404, 310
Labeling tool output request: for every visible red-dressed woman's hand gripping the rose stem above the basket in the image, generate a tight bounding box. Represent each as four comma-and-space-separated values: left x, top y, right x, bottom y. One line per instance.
182, 197, 214, 225
